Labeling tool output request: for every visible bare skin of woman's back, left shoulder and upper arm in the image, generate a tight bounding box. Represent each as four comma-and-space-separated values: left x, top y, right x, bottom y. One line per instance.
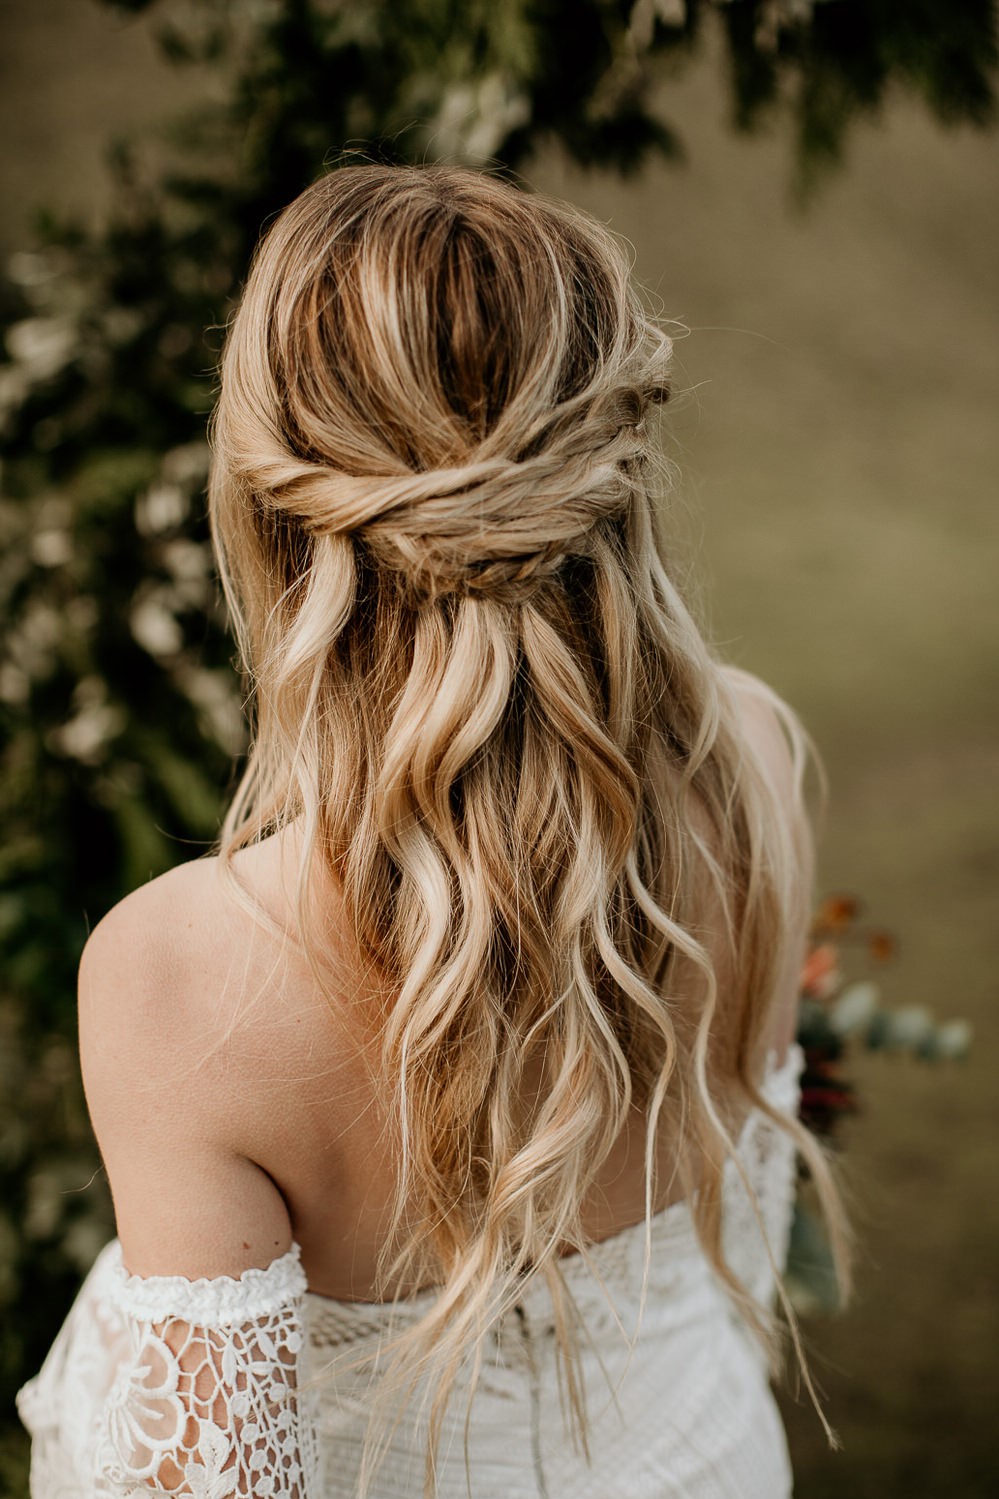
81, 678, 797, 1301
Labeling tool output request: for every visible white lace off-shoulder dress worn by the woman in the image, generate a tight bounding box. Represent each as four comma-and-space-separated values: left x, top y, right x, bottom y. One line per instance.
18, 1048, 803, 1499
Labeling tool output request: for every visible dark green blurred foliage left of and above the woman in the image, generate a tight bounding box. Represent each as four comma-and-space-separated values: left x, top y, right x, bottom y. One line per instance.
0, 0, 996, 1463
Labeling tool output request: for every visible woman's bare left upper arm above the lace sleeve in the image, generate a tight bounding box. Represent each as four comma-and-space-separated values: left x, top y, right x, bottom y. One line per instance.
80, 869, 291, 1279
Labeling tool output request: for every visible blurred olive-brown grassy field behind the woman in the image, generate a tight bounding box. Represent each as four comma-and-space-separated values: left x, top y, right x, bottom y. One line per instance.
0, 0, 999, 1499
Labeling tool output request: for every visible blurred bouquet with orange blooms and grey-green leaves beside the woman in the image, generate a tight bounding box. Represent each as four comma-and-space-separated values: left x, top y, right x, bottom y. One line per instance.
785, 895, 972, 1313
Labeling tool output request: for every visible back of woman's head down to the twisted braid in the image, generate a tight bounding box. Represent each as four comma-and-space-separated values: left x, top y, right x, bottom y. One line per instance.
216, 166, 669, 601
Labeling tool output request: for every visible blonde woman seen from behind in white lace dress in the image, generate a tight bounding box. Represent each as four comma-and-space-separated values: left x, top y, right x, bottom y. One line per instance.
21, 166, 839, 1499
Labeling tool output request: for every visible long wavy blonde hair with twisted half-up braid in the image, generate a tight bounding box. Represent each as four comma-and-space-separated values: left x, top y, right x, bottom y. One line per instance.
210, 165, 842, 1475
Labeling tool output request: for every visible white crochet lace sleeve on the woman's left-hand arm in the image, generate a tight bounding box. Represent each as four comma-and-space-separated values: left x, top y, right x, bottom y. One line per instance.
18, 1241, 321, 1499
